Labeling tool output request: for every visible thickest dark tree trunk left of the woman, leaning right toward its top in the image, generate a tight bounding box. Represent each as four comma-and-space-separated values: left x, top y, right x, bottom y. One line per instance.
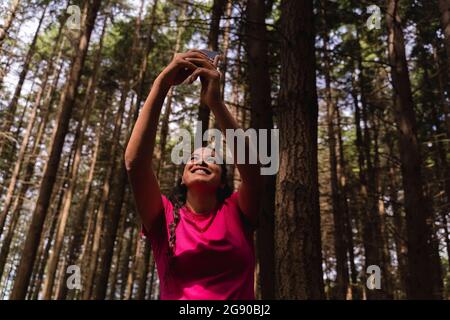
11, 0, 101, 299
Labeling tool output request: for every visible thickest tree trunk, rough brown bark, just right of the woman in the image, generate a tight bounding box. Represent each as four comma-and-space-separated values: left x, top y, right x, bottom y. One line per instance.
275, 0, 324, 299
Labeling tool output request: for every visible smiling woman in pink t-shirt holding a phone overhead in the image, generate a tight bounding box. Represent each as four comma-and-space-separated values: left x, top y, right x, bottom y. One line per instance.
125, 49, 261, 299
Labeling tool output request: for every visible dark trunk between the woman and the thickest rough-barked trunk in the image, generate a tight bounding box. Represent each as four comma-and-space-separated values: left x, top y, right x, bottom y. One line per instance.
245, 0, 276, 299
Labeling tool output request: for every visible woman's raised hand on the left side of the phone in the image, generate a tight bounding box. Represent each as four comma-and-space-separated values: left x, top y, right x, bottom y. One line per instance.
158, 49, 209, 87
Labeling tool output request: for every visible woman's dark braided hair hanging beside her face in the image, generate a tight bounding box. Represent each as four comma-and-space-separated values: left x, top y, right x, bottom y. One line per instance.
168, 163, 233, 260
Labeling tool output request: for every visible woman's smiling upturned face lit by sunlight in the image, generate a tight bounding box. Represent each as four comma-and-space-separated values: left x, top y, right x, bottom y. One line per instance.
183, 148, 222, 190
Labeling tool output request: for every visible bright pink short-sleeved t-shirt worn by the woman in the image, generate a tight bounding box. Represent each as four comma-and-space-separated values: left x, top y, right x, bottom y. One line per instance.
143, 192, 255, 300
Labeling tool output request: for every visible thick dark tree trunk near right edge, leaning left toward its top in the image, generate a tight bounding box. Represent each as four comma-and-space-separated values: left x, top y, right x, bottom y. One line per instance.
386, 0, 438, 299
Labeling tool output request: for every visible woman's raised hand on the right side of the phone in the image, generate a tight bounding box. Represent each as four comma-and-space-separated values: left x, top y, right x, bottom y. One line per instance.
185, 50, 222, 108
